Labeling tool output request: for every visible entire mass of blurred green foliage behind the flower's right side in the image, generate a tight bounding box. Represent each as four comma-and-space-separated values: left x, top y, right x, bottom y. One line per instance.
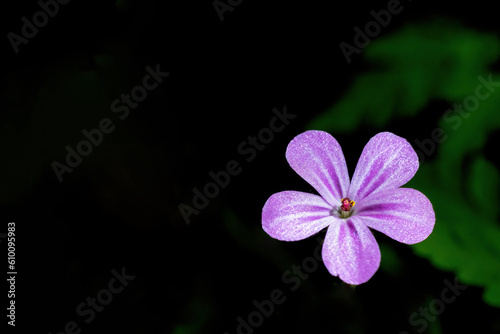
307, 20, 500, 308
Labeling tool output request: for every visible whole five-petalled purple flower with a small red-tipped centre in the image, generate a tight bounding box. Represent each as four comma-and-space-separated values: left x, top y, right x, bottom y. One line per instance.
262, 131, 435, 284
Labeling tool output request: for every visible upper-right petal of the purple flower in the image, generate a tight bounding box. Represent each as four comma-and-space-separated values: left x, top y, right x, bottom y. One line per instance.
348, 132, 418, 202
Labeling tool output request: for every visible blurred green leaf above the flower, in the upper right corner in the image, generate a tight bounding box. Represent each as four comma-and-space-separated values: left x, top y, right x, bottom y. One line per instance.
307, 20, 500, 133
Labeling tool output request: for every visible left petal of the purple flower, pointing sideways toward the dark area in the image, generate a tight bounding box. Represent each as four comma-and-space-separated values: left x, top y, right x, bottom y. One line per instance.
262, 191, 339, 241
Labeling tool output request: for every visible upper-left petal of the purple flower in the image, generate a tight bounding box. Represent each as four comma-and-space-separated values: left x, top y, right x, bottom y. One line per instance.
286, 130, 349, 206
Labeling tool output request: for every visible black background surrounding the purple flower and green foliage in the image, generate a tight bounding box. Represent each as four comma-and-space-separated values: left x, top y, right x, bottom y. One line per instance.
0, 0, 500, 334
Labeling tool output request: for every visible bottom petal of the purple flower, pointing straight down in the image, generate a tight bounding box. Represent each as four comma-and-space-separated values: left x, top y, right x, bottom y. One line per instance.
322, 216, 380, 285
